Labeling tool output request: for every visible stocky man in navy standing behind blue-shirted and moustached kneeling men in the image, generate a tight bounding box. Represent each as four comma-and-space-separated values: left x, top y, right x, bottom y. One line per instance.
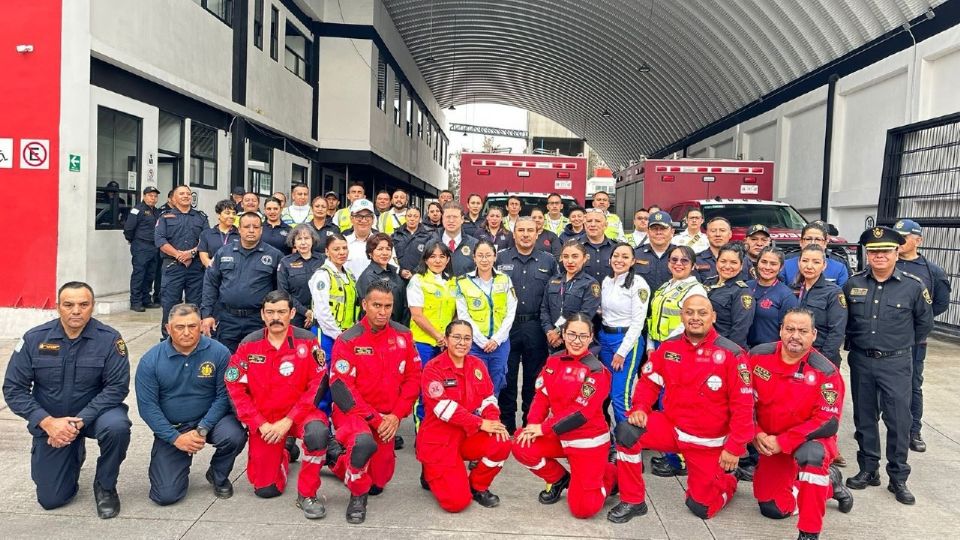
200, 212, 283, 352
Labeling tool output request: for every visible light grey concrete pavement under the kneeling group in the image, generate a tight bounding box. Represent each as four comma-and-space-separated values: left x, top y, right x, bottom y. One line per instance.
0, 310, 960, 540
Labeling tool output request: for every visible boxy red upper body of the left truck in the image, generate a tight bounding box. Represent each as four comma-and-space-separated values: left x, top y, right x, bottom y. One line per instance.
460, 153, 587, 207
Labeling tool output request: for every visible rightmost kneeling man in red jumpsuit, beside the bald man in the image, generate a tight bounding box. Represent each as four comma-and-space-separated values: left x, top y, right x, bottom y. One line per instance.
750, 308, 853, 540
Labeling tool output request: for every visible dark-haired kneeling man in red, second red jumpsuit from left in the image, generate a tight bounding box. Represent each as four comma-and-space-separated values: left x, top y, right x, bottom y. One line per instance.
330, 283, 420, 523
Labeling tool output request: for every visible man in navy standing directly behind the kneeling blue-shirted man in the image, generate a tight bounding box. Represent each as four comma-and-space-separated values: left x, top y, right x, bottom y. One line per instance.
153, 186, 209, 337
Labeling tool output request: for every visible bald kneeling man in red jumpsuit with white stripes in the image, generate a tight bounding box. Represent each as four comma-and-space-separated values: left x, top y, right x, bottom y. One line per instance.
607, 295, 754, 523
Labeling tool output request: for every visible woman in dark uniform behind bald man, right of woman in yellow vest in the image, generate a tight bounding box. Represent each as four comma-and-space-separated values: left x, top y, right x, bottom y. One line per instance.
704, 244, 757, 350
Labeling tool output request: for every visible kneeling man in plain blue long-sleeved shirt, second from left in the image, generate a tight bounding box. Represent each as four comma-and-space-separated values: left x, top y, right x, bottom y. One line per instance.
136, 304, 247, 506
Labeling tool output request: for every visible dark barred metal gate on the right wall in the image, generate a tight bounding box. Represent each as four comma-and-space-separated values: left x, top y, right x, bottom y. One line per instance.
877, 113, 960, 336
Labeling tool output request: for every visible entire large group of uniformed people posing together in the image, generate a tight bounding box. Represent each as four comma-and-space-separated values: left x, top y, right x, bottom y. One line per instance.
4, 184, 949, 537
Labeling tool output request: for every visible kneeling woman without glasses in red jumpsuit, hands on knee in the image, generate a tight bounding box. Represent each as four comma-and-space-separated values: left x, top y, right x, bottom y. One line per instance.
417, 320, 511, 512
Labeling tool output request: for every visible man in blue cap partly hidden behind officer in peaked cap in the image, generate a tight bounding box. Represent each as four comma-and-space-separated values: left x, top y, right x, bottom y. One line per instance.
893, 219, 950, 452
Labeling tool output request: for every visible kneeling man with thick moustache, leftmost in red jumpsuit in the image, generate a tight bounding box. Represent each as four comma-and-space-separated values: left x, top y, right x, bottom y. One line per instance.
224, 291, 330, 519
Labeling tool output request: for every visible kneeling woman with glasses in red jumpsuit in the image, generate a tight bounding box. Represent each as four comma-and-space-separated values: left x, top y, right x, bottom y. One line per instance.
513, 313, 616, 519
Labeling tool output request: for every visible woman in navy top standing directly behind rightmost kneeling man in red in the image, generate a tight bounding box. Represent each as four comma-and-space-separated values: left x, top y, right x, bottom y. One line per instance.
747, 246, 797, 347
